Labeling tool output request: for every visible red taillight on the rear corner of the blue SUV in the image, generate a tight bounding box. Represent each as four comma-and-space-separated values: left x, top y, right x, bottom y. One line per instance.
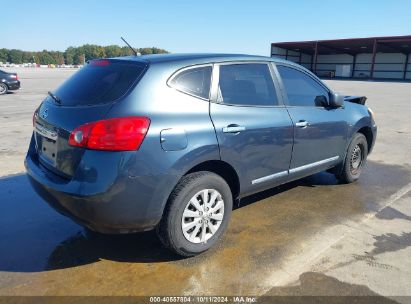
69, 117, 150, 151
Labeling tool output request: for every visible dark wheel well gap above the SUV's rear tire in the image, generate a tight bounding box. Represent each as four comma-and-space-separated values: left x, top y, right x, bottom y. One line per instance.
185, 160, 240, 199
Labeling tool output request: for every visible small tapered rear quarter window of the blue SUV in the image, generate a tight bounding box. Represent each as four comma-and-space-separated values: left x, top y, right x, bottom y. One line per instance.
169, 66, 212, 99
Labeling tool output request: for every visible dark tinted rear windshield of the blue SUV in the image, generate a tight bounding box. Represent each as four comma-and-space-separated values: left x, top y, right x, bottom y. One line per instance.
49, 60, 145, 106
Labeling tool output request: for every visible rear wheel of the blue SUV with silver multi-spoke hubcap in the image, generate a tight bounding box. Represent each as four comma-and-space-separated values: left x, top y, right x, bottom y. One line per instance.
157, 171, 233, 257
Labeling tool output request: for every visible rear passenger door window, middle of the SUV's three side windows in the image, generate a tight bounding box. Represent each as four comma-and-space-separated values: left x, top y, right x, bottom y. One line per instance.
217, 63, 278, 106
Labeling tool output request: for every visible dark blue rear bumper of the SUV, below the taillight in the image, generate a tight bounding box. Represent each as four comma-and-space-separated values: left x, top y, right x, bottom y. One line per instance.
25, 144, 176, 234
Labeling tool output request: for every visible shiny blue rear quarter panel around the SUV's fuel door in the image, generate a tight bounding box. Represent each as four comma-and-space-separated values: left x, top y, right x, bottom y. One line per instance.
107, 63, 220, 211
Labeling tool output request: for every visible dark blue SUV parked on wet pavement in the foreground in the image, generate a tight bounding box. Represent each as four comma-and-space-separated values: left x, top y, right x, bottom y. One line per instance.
25, 54, 377, 256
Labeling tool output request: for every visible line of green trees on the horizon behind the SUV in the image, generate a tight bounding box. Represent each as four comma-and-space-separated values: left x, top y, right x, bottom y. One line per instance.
0, 44, 168, 65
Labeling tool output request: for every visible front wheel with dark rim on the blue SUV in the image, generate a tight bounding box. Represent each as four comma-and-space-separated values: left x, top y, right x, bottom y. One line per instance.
336, 133, 368, 184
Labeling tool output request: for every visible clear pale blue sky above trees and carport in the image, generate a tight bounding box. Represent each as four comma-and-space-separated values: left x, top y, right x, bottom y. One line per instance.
0, 0, 411, 55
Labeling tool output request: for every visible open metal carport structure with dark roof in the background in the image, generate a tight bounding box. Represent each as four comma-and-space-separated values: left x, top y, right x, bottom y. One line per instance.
271, 35, 411, 80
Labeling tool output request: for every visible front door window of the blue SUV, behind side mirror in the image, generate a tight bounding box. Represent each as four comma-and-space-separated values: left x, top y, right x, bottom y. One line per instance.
277, 65, 329, 107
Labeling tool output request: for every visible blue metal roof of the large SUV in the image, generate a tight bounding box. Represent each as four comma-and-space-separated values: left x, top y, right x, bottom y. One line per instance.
117, 53, 295, 65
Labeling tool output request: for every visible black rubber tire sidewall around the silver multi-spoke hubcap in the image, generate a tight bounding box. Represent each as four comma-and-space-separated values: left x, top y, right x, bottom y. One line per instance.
167, 173, 233, 255
